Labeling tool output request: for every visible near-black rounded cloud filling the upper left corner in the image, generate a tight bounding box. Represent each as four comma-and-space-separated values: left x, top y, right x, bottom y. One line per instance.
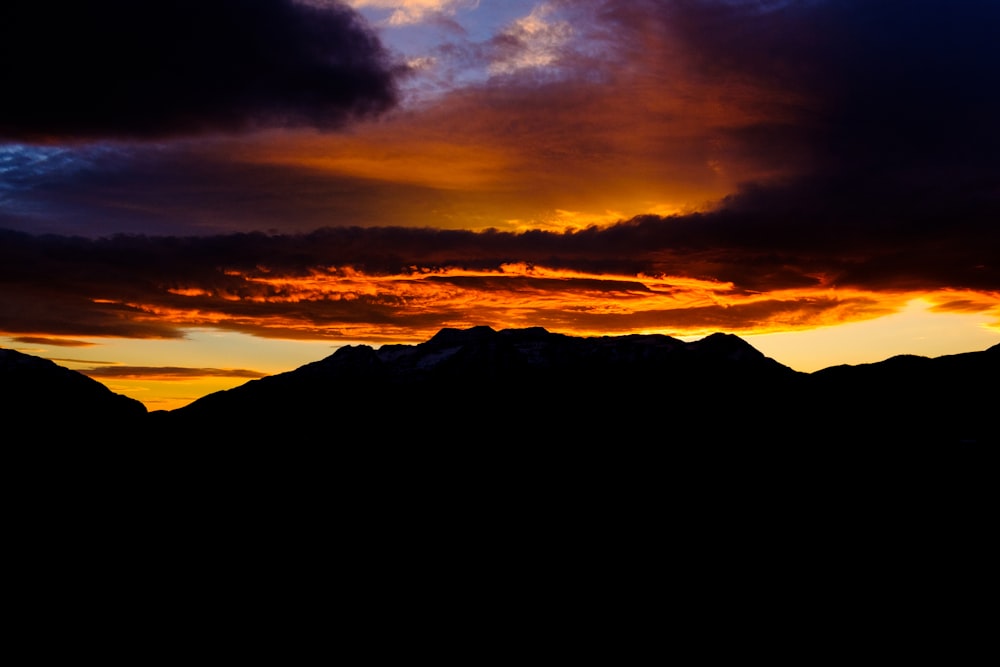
0, 0, 396, 140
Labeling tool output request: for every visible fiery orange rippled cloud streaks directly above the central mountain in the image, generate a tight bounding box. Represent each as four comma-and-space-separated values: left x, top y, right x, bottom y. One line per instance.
99, 262, 912, 341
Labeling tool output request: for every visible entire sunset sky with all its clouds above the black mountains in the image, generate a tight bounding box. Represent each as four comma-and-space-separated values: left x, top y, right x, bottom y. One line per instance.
0, 0, 1000, 410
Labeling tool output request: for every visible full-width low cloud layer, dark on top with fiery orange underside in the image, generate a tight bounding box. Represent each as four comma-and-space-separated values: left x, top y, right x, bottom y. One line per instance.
0, 217, 1000, 348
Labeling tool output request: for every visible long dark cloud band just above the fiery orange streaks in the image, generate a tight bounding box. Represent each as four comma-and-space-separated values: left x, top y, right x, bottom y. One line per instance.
0, 217, 1000, 300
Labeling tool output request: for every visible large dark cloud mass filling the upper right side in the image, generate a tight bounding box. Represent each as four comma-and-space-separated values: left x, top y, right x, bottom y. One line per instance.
584, 0, 1000, 290
